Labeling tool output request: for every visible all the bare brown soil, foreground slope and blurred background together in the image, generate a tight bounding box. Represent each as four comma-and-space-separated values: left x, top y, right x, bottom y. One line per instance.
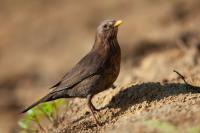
0, 0, 200, 133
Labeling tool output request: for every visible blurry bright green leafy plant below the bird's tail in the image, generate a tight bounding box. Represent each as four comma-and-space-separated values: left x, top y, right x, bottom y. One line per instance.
18, 99, 67, 132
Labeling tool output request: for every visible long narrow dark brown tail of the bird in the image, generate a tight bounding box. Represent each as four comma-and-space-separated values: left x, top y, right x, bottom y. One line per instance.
21, 93, 61, 113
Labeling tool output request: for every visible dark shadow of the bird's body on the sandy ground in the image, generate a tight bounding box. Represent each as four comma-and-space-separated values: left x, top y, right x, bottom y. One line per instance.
106, 82, 200, 112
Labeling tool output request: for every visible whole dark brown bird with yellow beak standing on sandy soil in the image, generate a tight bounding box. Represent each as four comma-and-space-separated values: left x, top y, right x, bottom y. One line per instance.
22, 19, 122, 125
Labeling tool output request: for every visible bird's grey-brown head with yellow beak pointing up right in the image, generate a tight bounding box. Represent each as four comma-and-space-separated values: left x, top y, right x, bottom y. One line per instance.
97, 19, 122, 40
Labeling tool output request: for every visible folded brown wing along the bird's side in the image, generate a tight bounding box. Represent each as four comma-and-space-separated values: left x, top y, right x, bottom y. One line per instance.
52, 52, 105, 92
